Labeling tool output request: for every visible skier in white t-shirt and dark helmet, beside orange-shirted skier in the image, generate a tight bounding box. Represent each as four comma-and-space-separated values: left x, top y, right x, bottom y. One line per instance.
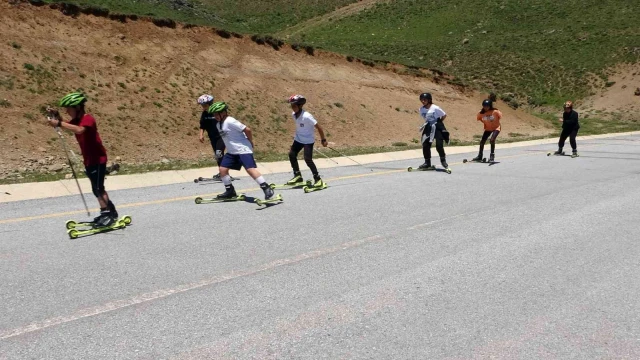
420, 93, 451, 172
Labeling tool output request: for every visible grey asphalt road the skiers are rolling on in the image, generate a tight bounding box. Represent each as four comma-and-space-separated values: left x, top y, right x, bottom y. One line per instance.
0, 136, 640, 359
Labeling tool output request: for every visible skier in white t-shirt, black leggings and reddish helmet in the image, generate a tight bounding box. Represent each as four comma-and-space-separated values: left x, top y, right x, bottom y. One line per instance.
287, 95, 327, 187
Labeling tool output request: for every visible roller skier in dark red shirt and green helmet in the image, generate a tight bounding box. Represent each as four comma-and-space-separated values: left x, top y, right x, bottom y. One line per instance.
47, 92, 118, 226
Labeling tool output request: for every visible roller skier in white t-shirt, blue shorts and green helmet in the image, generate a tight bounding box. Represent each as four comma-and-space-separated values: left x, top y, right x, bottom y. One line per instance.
209, 101, 274, 200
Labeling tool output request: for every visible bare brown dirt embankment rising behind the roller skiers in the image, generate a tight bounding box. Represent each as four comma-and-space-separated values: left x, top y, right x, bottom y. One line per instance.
0, 1, 549, 176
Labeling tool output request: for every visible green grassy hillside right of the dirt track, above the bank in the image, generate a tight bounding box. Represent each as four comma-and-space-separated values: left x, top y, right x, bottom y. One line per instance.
298, 0, 640, 105
